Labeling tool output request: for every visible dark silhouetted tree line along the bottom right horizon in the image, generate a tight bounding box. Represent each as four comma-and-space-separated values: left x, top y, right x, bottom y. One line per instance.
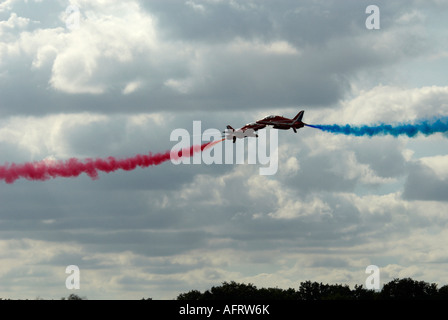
176, 278, 448, 300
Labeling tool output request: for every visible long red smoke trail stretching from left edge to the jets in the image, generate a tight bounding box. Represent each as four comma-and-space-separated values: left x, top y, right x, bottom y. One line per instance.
0, 140, 222, 183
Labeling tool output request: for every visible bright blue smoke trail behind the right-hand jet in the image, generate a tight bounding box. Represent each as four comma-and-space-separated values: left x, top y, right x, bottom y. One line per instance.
306, 117, 448, 138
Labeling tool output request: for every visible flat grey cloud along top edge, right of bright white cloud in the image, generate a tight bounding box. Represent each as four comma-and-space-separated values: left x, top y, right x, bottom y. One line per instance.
143, 0, 403, 46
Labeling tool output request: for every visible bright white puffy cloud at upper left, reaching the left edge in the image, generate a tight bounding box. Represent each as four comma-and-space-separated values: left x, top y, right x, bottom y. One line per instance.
0, 1, 160, 94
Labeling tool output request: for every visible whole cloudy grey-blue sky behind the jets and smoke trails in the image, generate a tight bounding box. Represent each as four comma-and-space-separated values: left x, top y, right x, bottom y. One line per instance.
0, 0, 448, 299
